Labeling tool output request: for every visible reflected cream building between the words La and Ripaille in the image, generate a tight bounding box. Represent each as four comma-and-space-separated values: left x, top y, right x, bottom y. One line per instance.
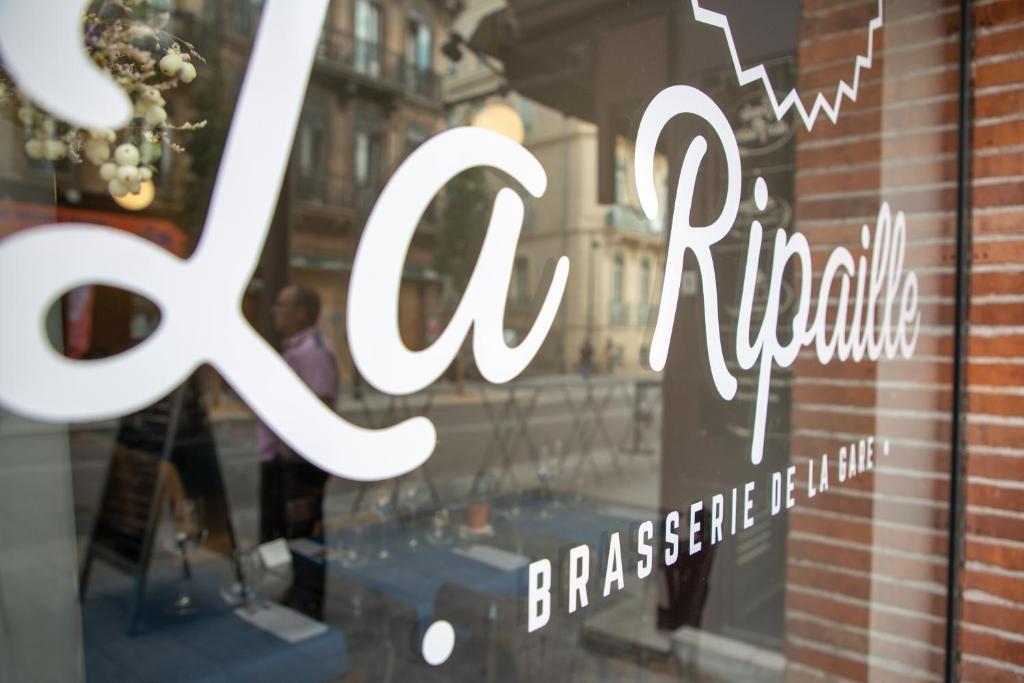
443, 0, 668, 374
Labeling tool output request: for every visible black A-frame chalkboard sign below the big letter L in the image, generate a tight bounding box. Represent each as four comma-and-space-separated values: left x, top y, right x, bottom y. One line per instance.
80, 376, 241, 632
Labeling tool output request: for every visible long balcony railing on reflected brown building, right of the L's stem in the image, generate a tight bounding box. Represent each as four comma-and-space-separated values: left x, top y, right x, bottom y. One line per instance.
318, 31, 440, 100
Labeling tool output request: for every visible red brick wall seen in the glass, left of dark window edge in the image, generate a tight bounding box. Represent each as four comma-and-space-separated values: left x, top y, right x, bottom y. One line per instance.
785, 0, 959, 681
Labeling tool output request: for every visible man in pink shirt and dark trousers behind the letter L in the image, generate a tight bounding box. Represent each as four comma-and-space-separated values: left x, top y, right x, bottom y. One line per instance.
259, 286, 339, 542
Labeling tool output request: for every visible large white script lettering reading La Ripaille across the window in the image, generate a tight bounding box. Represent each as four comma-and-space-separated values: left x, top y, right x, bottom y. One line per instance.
0, 0, 921, 481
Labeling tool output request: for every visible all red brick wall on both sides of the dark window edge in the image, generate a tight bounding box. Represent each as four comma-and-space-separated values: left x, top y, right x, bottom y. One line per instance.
786, 0, 1024, 682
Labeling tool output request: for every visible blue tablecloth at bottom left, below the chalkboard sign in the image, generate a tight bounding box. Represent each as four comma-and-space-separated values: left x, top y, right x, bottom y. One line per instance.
82, 577, 346, 683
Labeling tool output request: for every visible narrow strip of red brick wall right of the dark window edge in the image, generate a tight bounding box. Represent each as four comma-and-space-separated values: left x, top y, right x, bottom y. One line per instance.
961, 0, 1024, 682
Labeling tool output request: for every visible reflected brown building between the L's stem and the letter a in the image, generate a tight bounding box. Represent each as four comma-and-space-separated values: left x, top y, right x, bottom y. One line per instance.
211, 0, 458, 381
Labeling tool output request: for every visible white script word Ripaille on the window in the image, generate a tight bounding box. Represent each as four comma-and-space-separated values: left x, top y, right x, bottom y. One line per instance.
635, 86, 921, 465
